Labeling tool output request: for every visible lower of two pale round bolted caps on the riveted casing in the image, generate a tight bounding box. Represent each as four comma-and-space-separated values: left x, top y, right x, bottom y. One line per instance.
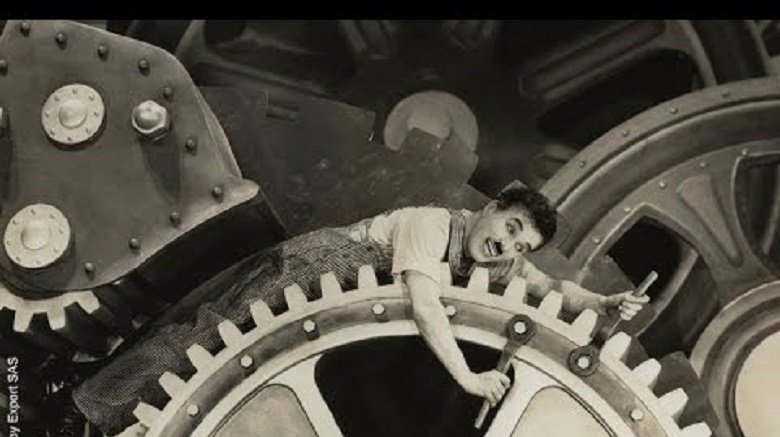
3, 204, 71, 269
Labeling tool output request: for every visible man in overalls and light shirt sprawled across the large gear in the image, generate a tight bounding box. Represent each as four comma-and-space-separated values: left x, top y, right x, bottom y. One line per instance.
74, 183, 648, 435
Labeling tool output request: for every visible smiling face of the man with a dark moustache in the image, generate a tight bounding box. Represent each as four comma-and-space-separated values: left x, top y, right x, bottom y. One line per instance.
466, 201, 544, 262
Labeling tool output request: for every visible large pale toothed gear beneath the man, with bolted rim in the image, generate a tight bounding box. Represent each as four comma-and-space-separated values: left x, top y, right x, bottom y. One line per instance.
122, 264, 710, 437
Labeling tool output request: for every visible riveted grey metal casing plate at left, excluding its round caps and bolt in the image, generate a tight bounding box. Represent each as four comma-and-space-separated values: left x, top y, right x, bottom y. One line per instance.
0, 21, 257, 293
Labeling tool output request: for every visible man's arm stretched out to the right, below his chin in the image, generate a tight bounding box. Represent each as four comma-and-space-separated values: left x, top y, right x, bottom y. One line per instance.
520, 259, 650, 320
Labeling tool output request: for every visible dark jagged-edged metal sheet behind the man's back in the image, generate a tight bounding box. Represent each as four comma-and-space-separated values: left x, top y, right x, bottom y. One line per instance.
203, 87, 487, 235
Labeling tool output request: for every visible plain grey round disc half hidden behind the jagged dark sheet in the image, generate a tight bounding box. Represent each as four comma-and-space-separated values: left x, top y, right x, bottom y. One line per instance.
384, 91, 479, 151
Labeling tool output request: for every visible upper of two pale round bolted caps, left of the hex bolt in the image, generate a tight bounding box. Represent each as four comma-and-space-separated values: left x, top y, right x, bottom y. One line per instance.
41, 83, 105, 145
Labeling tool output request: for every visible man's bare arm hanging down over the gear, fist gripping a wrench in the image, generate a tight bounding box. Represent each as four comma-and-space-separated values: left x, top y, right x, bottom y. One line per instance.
403, 270, 510, 406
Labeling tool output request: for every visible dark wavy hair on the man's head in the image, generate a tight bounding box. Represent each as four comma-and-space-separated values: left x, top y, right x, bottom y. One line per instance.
495, 184, 558, 245
